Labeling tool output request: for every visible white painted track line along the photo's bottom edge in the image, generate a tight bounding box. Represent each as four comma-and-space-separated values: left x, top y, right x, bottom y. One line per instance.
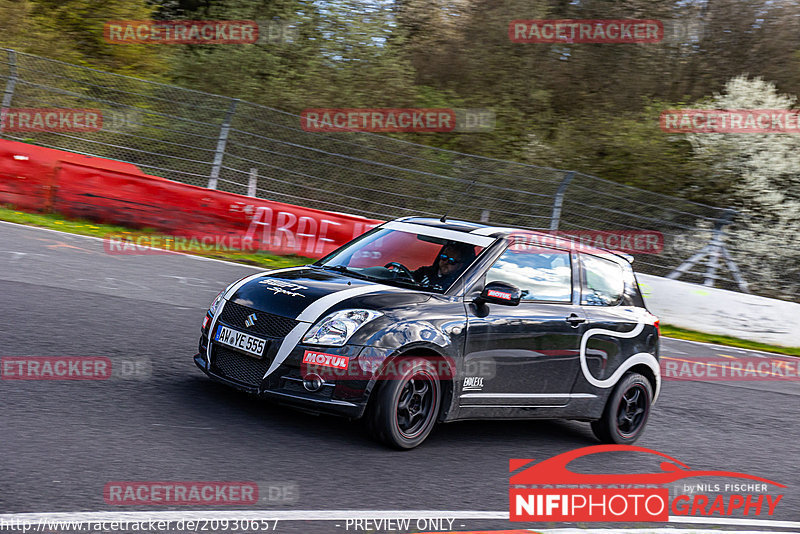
0, 510, 800, 532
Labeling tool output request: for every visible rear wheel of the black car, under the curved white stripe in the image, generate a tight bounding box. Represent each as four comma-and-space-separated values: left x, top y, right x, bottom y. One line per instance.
592, 373, 653, 445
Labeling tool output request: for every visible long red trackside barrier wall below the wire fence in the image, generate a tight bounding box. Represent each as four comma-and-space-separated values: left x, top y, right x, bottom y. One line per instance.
0, 140, 382, 258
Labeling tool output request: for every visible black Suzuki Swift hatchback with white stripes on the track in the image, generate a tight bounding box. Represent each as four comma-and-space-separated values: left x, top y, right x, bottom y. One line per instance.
194, 218, 661, 448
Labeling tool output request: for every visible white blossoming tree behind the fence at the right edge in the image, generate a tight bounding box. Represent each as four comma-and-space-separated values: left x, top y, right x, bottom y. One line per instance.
689, 76, 800, 301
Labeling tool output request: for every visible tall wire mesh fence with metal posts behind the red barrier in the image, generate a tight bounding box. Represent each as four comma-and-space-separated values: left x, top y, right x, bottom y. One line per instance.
0, 49, 768, 298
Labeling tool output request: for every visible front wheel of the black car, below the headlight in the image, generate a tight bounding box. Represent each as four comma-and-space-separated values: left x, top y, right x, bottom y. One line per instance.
367, 358, 442, 449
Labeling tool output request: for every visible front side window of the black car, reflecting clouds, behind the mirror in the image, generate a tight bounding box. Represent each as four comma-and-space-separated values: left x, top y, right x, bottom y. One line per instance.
486, 244, 572, 302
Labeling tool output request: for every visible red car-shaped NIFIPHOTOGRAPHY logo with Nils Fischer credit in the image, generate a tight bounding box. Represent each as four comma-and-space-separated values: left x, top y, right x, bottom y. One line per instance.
509, 445, 786, 522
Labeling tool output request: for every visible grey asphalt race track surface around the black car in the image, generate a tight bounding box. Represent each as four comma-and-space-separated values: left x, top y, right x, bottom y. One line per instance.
0, 223, 800, 532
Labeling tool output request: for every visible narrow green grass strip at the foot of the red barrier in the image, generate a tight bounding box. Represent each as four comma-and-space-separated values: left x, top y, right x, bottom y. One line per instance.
0, 207, 314, 269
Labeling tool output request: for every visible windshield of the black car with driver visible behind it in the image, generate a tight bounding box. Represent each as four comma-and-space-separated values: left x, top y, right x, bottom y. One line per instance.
314, 228, 484, 293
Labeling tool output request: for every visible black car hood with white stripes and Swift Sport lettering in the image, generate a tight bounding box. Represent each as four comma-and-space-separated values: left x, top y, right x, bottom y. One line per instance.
226, 267, 430, 322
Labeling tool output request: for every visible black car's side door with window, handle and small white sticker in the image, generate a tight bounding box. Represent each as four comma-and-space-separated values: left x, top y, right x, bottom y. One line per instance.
459, 243, 586, 407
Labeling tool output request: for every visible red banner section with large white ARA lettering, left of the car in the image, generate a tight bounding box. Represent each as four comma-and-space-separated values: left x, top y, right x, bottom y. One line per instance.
53, 162, 381, 258
